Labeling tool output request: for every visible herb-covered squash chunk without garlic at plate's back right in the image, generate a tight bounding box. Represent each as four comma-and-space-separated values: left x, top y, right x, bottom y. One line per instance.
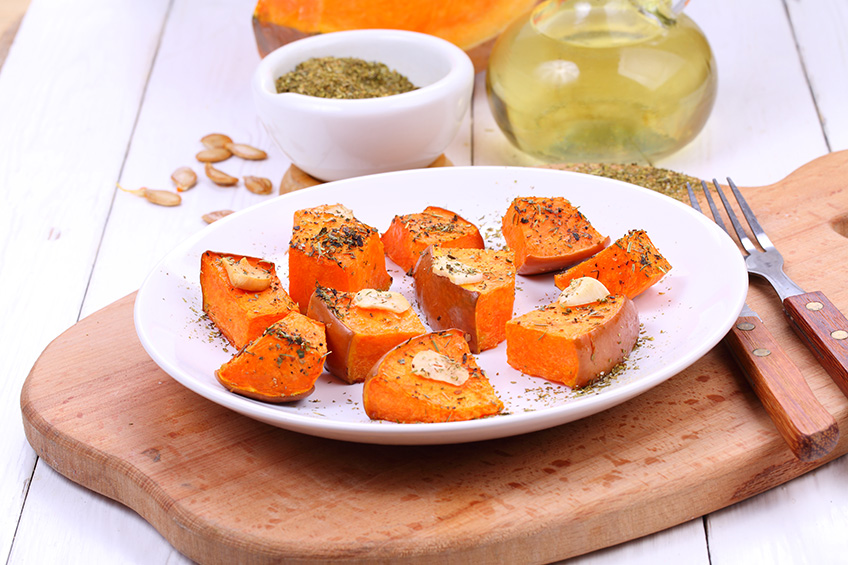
502, 196, 609, 275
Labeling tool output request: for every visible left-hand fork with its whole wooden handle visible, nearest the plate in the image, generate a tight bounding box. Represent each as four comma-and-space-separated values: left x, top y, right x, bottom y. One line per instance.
686, 178, 839, 461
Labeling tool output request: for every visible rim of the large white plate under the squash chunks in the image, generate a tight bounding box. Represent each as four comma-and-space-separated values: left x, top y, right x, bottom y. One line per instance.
134, 166, 748, 445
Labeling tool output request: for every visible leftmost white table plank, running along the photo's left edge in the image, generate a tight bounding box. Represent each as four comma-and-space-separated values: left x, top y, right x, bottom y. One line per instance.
0, 0, 167, 555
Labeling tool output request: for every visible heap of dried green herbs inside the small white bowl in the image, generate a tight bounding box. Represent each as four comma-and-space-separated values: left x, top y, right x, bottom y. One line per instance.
275, 57, 417, 99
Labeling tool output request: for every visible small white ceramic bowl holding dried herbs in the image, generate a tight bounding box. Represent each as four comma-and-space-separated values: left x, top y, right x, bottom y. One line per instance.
253, 29, 474, 181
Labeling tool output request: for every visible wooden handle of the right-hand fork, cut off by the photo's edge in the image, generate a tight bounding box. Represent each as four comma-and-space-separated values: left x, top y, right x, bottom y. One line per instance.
783, 291, 848, 396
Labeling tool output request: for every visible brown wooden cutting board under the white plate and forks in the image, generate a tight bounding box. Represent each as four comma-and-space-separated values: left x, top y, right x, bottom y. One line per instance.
21, 152, 848, 564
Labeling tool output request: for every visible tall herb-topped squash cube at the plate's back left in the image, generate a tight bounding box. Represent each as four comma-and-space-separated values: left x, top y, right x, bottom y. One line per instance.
289, 204, 392, 313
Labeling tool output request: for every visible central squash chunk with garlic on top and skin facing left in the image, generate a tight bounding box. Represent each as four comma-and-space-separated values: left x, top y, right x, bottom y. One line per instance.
412, 247, 515, 353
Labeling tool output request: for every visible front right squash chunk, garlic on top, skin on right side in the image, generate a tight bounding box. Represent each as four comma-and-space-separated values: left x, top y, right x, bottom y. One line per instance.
506, 290, 639, 387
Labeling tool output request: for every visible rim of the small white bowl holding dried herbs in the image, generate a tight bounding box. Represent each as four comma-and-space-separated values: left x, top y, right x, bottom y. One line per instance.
254, 29, 474, 114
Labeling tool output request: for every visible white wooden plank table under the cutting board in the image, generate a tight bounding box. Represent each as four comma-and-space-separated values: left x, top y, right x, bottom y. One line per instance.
0, 0, 848, 565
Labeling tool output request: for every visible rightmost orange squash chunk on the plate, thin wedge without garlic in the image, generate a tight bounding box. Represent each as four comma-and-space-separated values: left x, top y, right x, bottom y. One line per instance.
554, 230, 671, 298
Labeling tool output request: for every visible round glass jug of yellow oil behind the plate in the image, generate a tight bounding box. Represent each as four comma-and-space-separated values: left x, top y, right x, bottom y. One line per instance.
486, 0, 717, 164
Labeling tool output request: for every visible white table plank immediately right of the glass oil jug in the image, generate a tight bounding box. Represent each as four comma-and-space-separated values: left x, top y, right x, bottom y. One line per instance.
657, 0, 827, 186
